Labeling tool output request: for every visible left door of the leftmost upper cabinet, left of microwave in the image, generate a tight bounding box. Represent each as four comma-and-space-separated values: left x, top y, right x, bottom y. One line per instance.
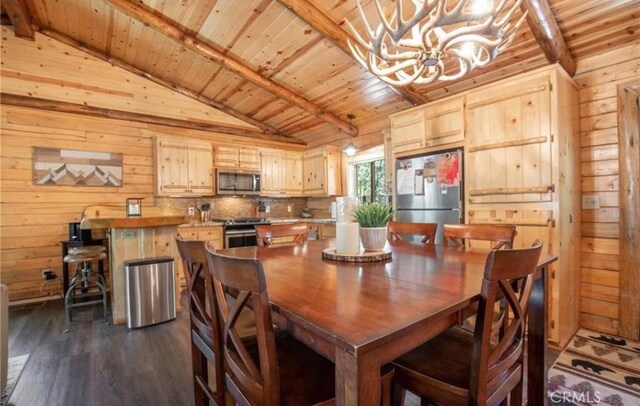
156, 139, 189, 195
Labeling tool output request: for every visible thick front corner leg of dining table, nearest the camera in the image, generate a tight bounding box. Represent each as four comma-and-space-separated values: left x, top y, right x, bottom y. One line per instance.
336, 348, 381, 406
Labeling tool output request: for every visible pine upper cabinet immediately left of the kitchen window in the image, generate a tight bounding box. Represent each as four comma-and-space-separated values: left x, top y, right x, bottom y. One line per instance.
302, 146, 342, 196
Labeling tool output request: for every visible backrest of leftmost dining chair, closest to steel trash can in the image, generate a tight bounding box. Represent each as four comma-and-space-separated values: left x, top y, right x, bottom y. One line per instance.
176, 235, 224, 405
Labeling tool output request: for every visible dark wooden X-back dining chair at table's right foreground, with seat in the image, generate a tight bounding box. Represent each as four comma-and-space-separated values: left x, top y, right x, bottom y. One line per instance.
393, 241, 544, 406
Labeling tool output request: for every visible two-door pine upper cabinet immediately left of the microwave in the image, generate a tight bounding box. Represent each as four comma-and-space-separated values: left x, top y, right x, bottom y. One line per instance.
154, 137, 214, 196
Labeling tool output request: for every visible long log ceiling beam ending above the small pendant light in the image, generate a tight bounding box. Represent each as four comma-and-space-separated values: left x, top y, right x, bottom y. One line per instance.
107, 0, 358, 136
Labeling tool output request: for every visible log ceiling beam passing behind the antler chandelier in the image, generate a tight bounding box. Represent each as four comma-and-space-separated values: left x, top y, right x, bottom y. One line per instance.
278, 0, 429, 106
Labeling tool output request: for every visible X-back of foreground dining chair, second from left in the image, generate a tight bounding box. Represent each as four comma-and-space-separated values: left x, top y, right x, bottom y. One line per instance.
208, 247, 280, 405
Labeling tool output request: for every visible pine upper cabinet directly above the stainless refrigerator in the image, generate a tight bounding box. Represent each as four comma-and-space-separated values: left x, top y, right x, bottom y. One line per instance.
391, 97, 464, 155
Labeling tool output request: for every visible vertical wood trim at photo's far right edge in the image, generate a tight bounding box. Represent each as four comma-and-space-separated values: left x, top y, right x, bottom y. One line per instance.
617, 82, 640, 340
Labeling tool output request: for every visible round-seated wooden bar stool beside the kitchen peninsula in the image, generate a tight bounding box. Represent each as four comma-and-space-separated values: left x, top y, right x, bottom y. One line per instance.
63, 245, 109, 323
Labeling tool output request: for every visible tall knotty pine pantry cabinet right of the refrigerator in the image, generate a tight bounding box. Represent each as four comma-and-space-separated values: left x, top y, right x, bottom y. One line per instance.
464, 66, 581, 346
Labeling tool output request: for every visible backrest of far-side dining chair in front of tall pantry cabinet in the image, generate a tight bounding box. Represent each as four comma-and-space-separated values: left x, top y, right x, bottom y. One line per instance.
443, 224, 517, 249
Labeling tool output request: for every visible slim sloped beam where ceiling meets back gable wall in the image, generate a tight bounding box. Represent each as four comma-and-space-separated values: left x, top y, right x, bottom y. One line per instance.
35, 28, 284, 139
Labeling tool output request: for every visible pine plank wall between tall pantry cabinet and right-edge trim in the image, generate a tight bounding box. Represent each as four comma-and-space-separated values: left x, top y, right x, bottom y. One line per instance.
575, 44, 640, 334
